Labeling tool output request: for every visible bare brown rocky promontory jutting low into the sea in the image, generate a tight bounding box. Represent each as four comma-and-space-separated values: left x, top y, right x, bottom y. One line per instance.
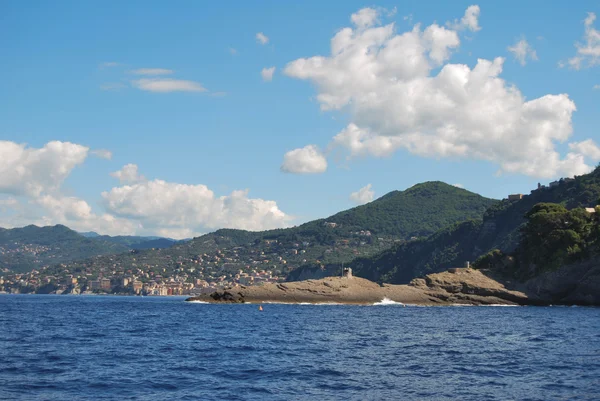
187, 268, 541, 305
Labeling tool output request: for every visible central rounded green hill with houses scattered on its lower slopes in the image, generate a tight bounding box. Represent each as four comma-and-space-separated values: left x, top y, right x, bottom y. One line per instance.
36, 182, 498, 278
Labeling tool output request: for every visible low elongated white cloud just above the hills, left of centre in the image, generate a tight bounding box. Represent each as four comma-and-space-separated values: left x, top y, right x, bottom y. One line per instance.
102, 180, 291, 236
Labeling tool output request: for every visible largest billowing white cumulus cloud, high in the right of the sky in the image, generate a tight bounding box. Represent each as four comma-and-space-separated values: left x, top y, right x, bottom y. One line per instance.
284, 8, 591, 178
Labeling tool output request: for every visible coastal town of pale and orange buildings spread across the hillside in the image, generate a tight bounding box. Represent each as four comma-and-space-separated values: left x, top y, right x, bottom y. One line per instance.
0, 227, 395, 296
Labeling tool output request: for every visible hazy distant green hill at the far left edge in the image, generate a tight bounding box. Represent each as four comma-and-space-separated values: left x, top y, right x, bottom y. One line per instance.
0, 225, 127, 271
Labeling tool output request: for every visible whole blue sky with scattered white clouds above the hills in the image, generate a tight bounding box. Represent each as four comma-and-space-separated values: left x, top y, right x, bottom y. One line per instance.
0, 0, 600, 238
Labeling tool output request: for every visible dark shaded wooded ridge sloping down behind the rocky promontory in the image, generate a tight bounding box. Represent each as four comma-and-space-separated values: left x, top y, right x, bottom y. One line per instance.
352, 169, 600, 283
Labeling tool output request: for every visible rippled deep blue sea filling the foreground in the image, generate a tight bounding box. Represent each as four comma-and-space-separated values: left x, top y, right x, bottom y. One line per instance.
0, 295, 600, 401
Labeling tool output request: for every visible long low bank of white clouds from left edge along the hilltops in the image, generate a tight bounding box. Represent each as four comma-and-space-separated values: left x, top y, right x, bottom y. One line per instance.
0, 141, 292, 238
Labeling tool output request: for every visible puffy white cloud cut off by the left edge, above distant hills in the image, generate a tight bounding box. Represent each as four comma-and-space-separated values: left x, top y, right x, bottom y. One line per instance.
0, 141, 89, 197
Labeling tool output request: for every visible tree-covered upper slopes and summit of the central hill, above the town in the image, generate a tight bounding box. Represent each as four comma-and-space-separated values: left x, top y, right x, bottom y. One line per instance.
154, 181, 498, 250
